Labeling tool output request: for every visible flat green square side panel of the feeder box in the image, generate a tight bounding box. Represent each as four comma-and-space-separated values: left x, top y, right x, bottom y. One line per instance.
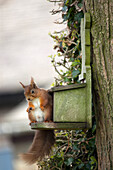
53, 88, 86, 122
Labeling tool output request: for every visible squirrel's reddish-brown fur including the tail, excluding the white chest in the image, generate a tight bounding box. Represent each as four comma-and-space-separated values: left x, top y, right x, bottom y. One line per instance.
20, 79, 55, 164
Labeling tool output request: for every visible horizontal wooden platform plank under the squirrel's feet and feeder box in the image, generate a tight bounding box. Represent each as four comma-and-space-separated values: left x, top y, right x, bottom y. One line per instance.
31, 122, 87, 130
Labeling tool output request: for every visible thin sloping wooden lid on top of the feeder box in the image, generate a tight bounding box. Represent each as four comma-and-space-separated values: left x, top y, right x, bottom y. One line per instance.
49, 83, 86, 92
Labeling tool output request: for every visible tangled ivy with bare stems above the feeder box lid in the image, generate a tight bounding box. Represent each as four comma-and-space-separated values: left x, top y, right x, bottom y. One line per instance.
49, 0, 84, 86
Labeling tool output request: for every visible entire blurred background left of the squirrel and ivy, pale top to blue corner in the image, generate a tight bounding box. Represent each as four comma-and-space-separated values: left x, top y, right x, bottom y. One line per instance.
0, 0, 61, 170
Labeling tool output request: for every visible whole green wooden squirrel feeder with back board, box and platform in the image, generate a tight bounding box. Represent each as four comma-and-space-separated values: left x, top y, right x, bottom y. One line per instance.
31, 13, 92, 130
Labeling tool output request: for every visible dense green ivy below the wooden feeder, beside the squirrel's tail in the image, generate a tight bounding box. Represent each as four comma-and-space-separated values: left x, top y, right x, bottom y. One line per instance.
39, 113, 97, 170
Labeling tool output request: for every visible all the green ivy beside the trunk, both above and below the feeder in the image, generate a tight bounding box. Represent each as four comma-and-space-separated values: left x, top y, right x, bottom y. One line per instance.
38, 0, 97, 170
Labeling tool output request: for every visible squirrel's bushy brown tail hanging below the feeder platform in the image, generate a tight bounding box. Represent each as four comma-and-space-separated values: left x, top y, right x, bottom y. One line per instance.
20, 130, 55, 164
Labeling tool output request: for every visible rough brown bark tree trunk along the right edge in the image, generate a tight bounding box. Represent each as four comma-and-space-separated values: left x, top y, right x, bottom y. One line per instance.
85, 0, 113, 170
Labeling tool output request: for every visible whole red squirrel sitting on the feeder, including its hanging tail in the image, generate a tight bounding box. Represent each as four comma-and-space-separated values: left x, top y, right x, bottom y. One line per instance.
20, 78, 55, 164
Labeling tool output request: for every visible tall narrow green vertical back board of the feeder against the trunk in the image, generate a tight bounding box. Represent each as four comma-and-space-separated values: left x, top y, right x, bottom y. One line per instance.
84, 13, 92, 128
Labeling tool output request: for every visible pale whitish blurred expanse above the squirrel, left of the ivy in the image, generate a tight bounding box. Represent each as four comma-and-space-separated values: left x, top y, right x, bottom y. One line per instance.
0, 0, 63, 92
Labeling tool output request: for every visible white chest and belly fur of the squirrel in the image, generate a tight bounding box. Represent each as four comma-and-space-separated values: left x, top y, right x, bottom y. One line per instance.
32, 98, 44, 122
